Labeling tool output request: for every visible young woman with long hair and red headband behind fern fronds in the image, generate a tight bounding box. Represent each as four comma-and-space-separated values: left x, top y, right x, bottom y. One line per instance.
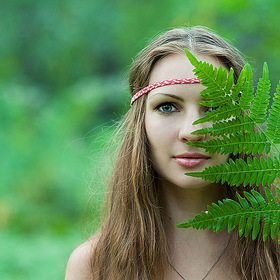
66, 27, 280, 280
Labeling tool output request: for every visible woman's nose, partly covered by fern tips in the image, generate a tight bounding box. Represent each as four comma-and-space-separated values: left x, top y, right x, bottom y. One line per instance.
179, 113, 206, 142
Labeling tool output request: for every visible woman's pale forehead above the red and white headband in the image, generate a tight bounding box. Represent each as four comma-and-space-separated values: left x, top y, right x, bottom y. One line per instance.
149, 54, 226, 84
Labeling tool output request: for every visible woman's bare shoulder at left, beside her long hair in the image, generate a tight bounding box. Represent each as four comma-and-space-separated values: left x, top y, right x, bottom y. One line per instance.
65, 235, 99, 280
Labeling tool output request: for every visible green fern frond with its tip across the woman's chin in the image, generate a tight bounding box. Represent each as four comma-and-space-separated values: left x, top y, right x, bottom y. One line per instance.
185, 157, 280, 187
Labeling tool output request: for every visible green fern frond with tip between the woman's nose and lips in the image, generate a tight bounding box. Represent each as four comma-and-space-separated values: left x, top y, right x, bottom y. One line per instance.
188, 132, 271, 155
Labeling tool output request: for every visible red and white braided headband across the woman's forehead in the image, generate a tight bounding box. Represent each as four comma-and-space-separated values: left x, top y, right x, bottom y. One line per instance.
130, 78, 200, 106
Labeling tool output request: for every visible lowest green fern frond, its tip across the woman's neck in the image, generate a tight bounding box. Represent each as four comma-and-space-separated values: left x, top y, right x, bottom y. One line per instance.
177, 187, 280, 244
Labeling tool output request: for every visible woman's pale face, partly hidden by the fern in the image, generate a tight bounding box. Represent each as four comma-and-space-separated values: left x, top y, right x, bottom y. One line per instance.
145, 54, 229, 189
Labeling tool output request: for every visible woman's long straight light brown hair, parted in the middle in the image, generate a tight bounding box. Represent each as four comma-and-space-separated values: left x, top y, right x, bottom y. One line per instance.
91, 27, 280, 280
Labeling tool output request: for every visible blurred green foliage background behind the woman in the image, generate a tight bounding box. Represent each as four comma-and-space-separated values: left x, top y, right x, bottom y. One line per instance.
0, 0, 280, 280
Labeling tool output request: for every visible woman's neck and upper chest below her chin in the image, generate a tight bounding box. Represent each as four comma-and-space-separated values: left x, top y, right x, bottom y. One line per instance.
160, 180, 237, 280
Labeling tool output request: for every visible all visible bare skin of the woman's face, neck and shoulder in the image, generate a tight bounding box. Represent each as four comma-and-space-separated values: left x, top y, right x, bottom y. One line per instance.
66, 54, 238, 280
